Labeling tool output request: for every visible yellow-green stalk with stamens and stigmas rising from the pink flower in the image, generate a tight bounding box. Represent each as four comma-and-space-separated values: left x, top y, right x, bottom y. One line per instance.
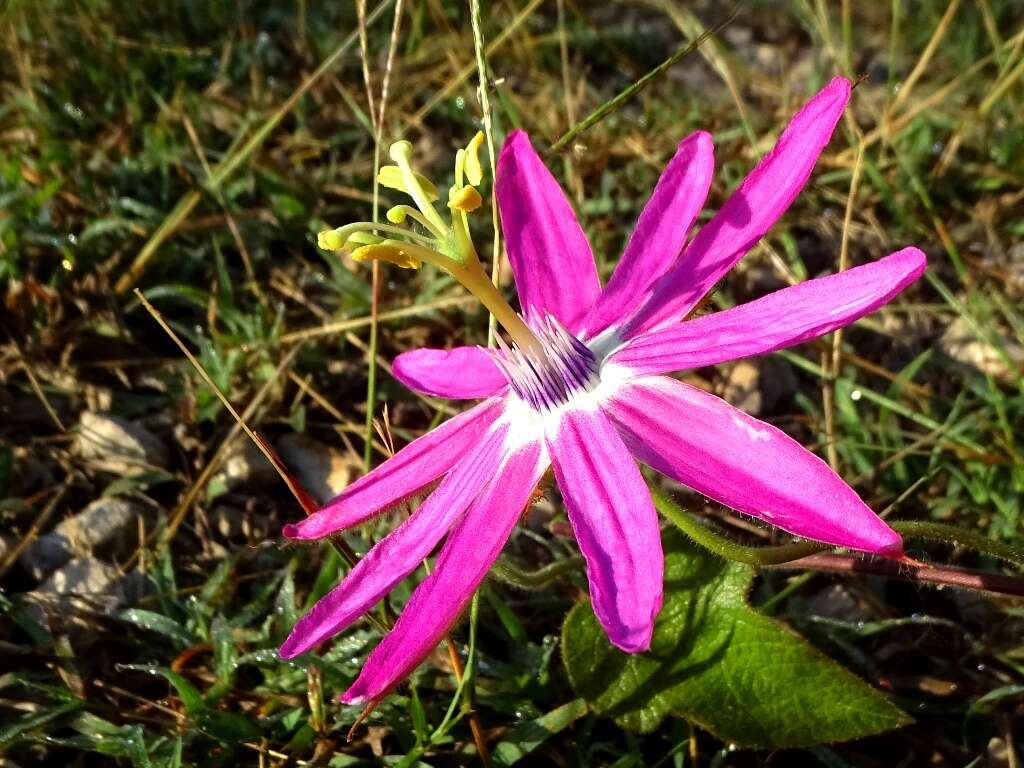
316, 131, 544, 355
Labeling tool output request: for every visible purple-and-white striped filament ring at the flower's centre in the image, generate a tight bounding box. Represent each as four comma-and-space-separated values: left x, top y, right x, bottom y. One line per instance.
490, 315, 600, 411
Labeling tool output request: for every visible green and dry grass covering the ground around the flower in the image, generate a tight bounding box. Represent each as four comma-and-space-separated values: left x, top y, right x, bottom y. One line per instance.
0, 0, 1024, 766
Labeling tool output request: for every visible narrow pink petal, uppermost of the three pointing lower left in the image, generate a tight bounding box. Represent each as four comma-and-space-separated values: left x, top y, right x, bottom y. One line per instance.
284, 397, 504, 540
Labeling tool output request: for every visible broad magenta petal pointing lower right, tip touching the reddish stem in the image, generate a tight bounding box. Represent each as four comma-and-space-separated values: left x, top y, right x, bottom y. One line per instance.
607, 376, 902, 555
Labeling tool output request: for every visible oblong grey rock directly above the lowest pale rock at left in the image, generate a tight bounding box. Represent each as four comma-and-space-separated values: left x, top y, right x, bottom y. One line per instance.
22, 498, 145, 580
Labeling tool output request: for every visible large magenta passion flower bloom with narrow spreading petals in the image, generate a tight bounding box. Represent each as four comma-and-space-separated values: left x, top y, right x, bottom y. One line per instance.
281, 78, 925, 703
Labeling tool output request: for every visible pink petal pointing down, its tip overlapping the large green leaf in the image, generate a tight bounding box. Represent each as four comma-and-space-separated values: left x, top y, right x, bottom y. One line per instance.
547, 410, 665, 653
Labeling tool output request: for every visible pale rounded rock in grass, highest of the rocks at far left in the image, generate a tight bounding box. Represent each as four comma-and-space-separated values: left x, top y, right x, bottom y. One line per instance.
76, 411, 170, 474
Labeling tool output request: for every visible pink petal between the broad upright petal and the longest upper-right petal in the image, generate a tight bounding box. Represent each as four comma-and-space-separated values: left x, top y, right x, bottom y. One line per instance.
584, 131, 715, 337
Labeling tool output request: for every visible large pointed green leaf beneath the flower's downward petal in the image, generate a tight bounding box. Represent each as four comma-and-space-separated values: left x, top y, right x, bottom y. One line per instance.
562, 531, 910, 749
